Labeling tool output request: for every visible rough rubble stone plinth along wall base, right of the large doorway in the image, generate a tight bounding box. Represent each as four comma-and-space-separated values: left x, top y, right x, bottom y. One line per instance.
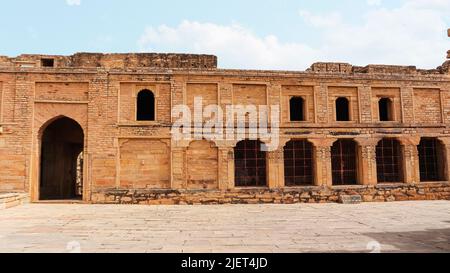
91, 182, 450, 205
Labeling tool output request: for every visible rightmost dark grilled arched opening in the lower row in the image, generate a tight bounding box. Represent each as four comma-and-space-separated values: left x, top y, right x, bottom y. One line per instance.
417, 138, 445, 182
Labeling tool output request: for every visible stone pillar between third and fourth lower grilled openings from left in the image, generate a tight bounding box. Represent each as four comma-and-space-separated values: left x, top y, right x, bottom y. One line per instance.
355, 138, 380, 185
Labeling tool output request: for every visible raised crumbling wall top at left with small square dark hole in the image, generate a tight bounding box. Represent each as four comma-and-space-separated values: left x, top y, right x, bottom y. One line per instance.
0, 53, 217, 69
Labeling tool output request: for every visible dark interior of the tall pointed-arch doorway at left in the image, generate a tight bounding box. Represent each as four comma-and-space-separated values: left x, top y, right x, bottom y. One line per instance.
39, 118, 84, 200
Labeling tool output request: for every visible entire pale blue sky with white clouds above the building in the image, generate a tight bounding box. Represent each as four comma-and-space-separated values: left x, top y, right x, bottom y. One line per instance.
0, 0, 450, 70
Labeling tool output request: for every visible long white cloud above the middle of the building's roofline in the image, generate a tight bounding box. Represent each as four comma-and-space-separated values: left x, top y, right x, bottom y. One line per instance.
138, 21, 318, 70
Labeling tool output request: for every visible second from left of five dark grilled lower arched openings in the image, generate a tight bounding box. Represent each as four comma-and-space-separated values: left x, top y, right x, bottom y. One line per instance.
284, 140, 314, 187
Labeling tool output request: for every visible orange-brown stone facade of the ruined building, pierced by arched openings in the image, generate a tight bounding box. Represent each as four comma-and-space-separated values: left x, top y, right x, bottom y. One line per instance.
0, 53, 450, 204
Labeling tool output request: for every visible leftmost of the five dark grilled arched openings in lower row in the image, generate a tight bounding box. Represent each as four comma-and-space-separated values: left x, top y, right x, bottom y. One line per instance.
234, 140, 267, 187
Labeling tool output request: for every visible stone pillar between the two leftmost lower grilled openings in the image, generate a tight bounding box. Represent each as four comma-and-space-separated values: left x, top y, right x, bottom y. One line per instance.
267, 147, 284, 189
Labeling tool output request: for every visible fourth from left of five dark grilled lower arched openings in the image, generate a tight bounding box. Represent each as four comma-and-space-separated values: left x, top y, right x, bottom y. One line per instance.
376, 138, 402, 183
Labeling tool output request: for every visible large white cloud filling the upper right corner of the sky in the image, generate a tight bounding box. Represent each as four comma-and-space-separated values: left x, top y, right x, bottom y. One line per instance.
303, 0, 450, 68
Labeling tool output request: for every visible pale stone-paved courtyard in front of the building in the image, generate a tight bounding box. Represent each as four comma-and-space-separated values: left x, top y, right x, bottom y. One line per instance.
0, 201, 450, 253
